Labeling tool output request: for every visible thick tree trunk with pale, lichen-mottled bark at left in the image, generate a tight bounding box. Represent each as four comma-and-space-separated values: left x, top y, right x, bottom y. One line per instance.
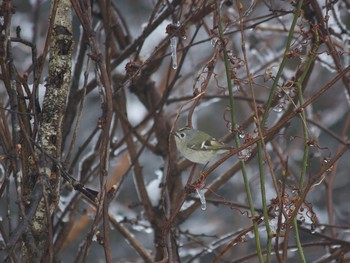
24, 0, 73, 261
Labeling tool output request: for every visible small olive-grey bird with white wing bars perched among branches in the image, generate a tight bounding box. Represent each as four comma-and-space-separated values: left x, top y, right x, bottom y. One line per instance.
172, 127, 232, 164
